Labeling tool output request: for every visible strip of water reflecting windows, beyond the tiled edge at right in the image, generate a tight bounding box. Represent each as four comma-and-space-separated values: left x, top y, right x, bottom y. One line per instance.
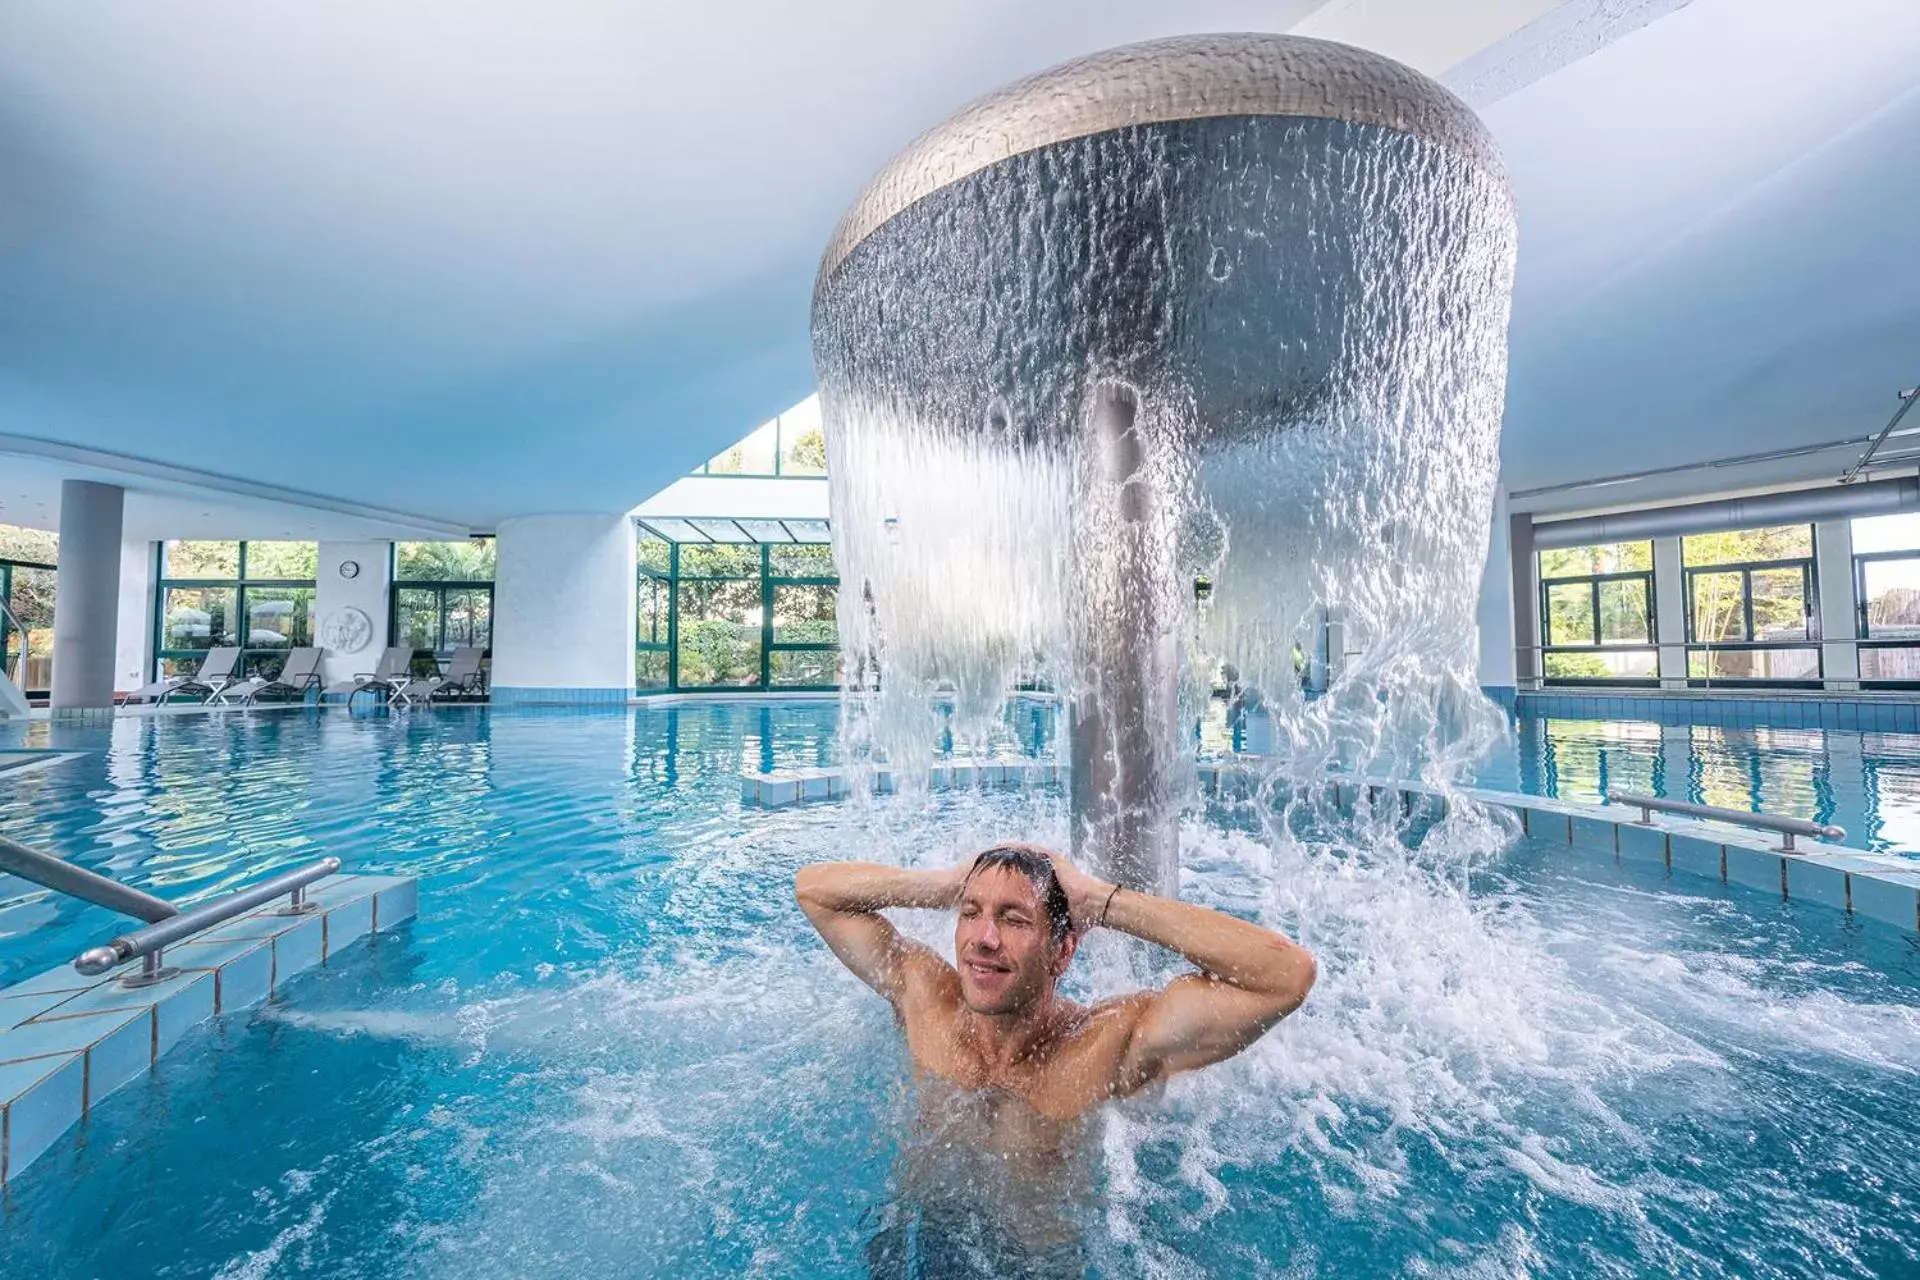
1478, 716, 1920, 858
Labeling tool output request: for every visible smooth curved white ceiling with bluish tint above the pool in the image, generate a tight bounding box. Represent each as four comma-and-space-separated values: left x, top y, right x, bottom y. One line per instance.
0, 0, 1920, 535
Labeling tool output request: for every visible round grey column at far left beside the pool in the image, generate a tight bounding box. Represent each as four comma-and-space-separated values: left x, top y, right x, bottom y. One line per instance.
52, 480, 127, 718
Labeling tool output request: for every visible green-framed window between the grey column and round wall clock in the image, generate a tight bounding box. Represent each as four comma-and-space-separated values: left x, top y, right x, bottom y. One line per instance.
154, 539, 319, 676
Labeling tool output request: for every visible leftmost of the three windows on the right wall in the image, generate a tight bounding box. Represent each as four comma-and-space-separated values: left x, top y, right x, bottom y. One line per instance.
1540, 541, 1659, 683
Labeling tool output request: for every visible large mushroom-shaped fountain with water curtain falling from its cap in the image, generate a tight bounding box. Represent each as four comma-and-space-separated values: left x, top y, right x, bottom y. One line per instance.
812, 35, 1515, 892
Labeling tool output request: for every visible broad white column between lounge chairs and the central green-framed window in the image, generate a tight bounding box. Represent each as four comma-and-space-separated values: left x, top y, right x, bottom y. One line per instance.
493, 512, 634, 704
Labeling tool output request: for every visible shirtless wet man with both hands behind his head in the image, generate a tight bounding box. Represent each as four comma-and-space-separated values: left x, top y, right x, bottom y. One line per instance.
793, 844, 1313, 1272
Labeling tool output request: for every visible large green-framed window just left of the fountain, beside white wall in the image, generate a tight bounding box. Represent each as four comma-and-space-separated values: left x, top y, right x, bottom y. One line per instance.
634, 520, 841, 689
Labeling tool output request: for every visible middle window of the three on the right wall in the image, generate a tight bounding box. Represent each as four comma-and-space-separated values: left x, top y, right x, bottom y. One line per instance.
1680, 524, 1820, 683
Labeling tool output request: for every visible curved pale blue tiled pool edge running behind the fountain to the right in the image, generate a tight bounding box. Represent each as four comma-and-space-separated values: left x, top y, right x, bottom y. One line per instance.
739, 760, 1920, 935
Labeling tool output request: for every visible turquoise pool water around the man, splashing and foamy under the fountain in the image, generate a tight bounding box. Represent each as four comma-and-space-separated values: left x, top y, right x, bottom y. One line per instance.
0, 704, 1920, 1280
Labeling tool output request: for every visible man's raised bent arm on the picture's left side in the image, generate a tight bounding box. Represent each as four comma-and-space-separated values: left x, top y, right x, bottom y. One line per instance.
793, 862, 966, 1000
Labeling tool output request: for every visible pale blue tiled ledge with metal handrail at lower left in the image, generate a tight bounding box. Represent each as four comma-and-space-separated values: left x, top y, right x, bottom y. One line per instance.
0, 875, 419, 1186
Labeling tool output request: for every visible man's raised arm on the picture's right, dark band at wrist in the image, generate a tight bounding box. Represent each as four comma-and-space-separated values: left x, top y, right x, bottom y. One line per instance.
1054, 854, 1315, 1094
